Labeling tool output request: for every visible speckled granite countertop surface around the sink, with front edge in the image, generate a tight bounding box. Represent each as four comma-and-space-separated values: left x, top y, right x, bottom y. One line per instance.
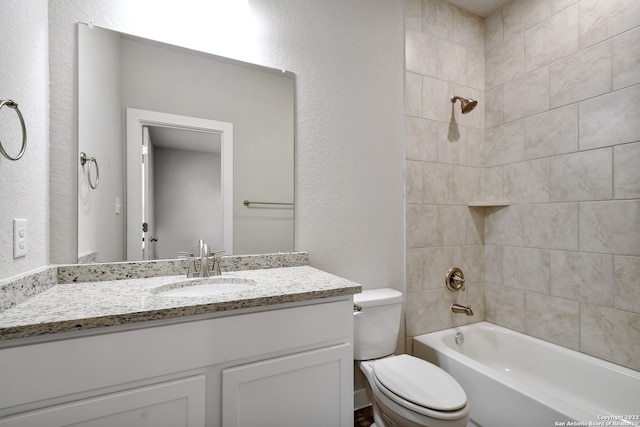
0, 265, 361, 341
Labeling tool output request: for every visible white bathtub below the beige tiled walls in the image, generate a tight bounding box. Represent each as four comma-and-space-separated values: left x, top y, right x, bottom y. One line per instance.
413, 322, 640, 427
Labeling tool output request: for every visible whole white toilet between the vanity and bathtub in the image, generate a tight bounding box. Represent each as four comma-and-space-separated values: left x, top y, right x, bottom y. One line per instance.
354, 288, 469, 427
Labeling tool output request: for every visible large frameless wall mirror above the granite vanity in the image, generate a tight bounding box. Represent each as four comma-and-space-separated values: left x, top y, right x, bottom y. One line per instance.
78, 24, 295, 262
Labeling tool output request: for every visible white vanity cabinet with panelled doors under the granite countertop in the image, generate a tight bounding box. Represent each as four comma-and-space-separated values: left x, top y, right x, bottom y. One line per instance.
0, 295, 353, 427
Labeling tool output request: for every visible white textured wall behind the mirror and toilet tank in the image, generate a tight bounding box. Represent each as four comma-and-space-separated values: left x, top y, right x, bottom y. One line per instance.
49, 0, 404, 289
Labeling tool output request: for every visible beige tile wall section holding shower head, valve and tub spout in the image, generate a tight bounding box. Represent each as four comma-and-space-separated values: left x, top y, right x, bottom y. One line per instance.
405, 0, 484, 348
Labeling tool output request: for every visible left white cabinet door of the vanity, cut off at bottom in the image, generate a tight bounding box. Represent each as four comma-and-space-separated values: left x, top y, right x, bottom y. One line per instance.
0, 375, 205, 427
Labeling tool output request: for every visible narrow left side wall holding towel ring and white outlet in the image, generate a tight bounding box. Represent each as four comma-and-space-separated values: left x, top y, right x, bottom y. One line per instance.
0, 0, 49, 279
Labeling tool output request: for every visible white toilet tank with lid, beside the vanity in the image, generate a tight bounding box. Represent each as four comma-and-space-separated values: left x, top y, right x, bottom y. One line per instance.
353, 288, 402, 360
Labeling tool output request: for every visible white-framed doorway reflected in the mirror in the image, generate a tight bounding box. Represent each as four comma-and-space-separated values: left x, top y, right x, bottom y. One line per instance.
126, 108, 233, 260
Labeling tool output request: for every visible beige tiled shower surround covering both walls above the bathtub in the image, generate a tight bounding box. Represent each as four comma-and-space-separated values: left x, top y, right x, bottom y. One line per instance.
405, 0, 640, 370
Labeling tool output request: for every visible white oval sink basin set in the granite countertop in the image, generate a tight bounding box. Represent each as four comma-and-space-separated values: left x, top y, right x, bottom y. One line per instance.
152, 277, 256, 297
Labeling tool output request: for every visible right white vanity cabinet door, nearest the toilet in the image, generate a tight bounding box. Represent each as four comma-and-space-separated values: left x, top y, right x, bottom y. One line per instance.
222, 343, 353, 427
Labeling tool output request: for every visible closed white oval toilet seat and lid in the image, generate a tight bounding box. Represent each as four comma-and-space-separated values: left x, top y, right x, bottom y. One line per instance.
373, 354, 467, 419
